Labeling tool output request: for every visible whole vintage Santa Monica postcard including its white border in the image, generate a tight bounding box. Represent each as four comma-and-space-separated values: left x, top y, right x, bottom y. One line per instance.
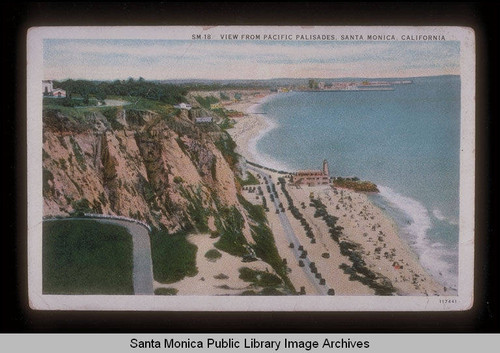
27, 26, 475, 311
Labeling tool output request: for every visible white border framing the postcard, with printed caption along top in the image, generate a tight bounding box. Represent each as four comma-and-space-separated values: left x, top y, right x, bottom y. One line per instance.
27, 26, 476, 311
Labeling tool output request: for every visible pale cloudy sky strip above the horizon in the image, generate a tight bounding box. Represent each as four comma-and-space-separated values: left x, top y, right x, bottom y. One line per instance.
43, 39, 460, 80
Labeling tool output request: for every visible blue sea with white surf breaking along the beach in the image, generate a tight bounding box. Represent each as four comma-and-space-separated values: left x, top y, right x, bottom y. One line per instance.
256, 76, 460, 289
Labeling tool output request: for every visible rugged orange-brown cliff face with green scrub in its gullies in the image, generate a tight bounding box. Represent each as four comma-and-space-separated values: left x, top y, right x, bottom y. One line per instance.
43, 108, 241, 232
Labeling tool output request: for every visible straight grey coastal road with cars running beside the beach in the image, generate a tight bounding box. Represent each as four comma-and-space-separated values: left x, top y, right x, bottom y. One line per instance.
247, 166, 330, 295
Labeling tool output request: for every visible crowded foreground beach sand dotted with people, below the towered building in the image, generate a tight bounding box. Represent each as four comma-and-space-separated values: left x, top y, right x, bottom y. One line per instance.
288, 186, 443, 295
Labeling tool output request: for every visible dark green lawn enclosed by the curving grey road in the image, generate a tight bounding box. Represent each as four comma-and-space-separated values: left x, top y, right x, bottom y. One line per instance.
43, 220, 134, 294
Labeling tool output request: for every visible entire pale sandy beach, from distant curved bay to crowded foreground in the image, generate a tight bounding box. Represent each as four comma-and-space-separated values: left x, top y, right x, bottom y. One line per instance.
229, 91, 450, 295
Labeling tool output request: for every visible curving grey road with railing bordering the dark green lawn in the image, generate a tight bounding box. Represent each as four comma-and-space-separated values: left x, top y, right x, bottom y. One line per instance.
46, 216, 154, 295
